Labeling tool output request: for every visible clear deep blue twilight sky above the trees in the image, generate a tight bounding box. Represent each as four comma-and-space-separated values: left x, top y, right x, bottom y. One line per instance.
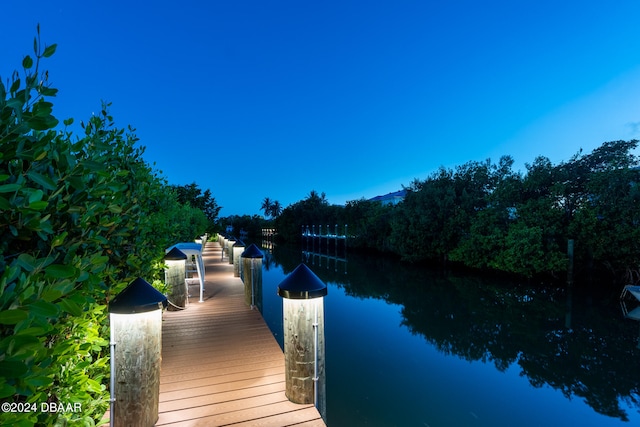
0, 0, 640, 216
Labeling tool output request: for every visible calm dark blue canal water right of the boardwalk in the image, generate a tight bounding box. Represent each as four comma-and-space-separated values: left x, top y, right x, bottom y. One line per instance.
252, 242, 640, 427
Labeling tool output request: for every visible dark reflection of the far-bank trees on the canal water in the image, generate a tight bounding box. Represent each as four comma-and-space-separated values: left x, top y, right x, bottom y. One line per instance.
272, 247, 640, 421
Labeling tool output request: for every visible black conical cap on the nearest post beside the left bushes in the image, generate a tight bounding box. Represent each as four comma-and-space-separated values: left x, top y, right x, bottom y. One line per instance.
109, 277, 168, 314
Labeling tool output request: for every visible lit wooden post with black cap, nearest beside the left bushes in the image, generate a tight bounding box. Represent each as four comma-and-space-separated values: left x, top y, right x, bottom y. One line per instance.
109, 278, 167, 427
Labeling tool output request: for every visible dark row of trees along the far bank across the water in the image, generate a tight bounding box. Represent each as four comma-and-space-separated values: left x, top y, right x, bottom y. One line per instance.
276, 140, 640, 282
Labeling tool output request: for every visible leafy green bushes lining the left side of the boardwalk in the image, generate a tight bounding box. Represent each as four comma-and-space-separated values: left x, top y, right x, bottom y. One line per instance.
0, 31, 208, 425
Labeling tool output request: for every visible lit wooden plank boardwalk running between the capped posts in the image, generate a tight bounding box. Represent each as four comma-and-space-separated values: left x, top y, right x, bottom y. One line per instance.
156, 242, 325, 427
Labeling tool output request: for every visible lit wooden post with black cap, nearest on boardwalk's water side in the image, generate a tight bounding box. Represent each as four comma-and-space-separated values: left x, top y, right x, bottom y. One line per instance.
278, 264, 327, 416
